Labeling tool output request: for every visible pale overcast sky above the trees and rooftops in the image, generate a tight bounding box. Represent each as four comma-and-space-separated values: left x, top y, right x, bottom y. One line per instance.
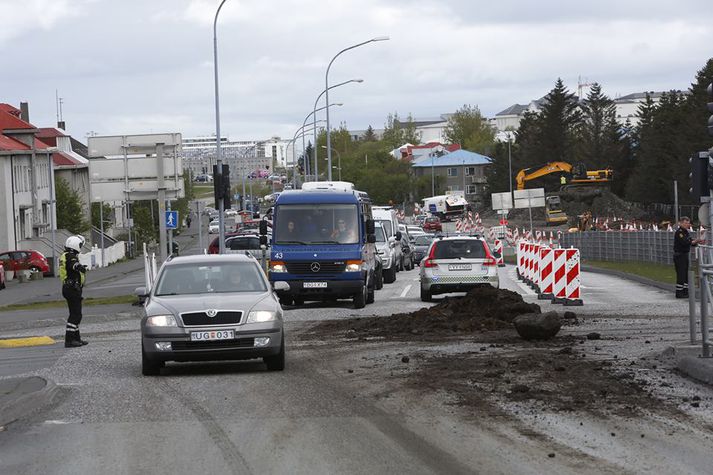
0, 0, 713, 141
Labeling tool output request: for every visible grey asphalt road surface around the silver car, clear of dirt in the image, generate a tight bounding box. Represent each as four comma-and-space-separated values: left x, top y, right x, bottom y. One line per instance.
0, 233, 700, 474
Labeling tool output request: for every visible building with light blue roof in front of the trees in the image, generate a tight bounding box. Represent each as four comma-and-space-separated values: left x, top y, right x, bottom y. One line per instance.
411, 149, 492, 203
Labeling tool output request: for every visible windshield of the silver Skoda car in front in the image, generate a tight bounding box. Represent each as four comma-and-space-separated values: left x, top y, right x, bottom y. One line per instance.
155, 262, 267, 296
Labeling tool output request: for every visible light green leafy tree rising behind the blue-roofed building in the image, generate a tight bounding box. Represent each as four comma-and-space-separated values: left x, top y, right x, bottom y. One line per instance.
444, 104, 495, 155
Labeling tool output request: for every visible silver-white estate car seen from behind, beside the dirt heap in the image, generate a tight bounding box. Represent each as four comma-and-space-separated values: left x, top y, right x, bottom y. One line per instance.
419, 236, 500, 302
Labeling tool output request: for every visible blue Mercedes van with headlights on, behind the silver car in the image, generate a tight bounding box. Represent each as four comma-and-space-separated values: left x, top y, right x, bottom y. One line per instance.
268, 182, 383, 308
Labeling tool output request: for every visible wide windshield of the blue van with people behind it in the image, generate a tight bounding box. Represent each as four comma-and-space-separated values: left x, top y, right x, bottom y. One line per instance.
273, 204, 360, 244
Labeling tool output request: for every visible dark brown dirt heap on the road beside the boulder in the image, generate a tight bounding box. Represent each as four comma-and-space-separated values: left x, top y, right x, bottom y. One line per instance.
313, 287, 540, 338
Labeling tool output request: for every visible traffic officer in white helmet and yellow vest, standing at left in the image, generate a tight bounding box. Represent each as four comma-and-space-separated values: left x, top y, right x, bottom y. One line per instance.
59, 236, 87, 348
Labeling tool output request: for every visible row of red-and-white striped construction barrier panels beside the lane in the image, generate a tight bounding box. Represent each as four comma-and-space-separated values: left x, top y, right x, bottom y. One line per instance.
517, 241, 583, 306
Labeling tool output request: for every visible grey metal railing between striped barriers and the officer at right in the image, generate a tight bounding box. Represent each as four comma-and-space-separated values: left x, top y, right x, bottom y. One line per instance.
559, 231, 674, 264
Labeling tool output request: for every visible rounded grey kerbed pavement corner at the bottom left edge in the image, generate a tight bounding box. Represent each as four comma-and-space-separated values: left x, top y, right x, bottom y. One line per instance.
0, 376, 58, 426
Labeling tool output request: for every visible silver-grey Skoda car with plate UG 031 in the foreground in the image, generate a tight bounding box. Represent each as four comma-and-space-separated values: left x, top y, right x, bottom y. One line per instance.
136, 254, 290, 376
